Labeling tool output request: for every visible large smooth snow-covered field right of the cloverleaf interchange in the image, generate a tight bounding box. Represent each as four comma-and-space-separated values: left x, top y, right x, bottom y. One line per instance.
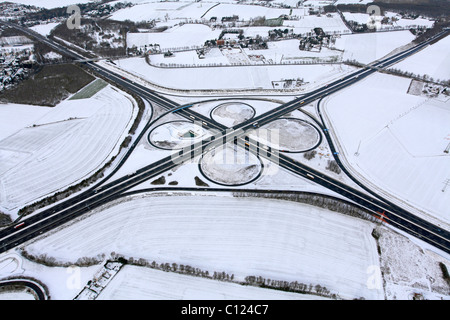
323, 74, 450, 229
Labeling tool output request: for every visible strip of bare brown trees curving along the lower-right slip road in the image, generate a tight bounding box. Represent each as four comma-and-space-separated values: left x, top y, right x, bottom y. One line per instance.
233, 191, 380, 224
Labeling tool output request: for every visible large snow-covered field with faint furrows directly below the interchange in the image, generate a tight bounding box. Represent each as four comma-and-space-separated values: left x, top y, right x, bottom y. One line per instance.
22, 195, 383, 299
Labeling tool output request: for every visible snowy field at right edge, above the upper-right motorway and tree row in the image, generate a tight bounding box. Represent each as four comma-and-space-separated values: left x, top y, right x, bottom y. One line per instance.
393, 36, 450, 80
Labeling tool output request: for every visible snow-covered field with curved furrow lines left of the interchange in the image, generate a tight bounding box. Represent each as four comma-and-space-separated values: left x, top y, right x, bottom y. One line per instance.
0, 86, 136, 213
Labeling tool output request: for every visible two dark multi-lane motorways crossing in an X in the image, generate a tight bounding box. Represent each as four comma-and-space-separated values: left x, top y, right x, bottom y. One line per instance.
0, 20, 450, 253
